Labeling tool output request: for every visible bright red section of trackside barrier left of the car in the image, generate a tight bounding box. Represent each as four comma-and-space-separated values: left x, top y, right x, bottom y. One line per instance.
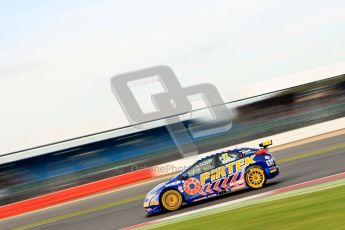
0, 168, 153, 219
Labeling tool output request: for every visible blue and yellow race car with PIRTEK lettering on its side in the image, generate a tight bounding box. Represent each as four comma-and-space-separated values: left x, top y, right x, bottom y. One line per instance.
144, 140, 279, 215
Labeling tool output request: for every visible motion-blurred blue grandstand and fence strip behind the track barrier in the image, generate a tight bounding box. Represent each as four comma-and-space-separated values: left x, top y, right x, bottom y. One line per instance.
0, 75, 345, 205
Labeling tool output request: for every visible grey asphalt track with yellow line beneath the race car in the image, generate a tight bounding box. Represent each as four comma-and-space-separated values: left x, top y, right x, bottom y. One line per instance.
0, 135, 345, 230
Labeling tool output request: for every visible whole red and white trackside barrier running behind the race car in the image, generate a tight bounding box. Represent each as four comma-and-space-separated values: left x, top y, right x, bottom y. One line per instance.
0, 117, 345, 219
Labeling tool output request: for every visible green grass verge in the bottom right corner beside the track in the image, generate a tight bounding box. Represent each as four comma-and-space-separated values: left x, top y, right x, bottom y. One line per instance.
151, 182, 345, 230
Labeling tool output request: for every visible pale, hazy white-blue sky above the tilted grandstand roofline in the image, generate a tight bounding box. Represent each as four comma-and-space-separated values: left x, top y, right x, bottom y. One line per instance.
0, 0, 345, 152
